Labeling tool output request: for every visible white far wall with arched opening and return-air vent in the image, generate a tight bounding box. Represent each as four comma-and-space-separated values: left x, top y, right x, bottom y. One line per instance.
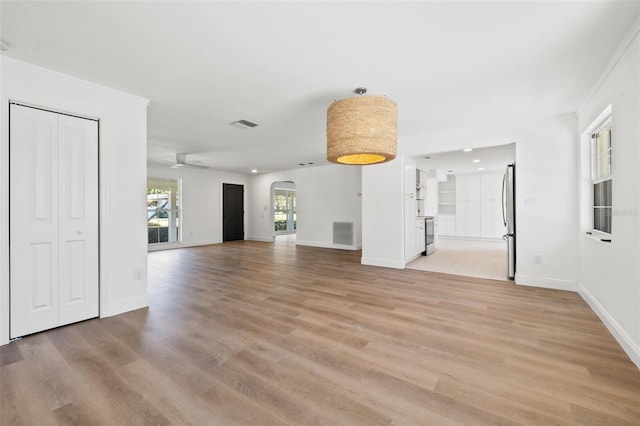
245, 165, 362, 249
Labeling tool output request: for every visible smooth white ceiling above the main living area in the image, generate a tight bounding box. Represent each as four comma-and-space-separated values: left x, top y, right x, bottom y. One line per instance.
0, 0, 640, 173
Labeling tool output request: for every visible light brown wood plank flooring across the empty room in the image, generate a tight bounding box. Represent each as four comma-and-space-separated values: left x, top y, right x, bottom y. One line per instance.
0, 241, 640, 426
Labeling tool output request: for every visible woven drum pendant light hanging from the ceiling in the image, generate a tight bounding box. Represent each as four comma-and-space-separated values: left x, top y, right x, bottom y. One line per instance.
327, 87, 398, 165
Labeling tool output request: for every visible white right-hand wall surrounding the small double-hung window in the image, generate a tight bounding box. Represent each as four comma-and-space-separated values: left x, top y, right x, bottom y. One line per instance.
577, 23, 640, 367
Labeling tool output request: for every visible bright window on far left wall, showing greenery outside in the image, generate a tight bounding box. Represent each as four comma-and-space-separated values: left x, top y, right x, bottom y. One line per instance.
147, 178, 180, 244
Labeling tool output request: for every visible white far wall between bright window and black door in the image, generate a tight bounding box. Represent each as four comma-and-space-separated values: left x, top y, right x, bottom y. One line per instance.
147, 164, 248, 250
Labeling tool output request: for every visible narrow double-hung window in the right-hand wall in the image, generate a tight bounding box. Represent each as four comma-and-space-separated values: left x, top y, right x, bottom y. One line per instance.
591, 119, 613, 234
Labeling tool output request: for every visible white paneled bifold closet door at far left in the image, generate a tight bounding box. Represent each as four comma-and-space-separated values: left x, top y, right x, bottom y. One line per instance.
9, 104, 99, 338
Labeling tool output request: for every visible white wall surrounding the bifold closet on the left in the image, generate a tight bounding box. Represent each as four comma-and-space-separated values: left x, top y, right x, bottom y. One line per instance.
0, 56, 148, 344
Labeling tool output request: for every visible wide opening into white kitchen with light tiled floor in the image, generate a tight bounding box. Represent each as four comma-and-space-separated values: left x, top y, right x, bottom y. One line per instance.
407, 143, 515, 281
